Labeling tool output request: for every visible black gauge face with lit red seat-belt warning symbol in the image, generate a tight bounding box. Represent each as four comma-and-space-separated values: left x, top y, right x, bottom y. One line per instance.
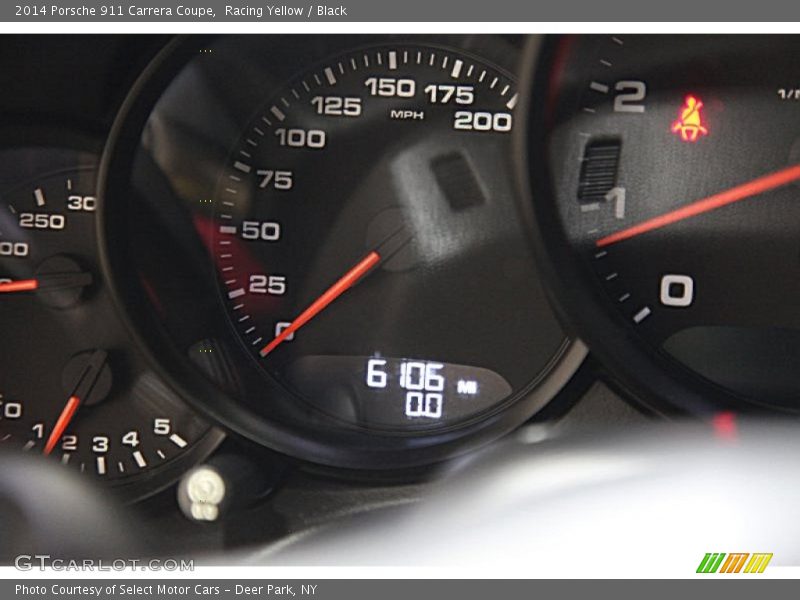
545, 36, 800, 408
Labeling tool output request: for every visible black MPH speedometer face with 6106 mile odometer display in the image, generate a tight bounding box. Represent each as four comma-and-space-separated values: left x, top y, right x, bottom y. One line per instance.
217, 45, 563, 429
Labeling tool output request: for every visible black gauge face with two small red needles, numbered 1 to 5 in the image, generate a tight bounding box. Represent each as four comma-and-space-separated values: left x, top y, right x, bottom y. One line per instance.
0, 148, 219, 494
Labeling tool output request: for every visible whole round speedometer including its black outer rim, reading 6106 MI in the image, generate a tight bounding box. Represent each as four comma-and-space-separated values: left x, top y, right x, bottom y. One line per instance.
101, 36, 583, 467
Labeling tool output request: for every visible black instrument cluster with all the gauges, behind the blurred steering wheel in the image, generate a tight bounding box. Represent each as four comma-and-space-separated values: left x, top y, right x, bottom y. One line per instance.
0, 34, 800, 552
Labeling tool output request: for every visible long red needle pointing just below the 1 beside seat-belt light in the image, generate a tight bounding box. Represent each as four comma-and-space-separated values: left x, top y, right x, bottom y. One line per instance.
595, 165, 800, 248
